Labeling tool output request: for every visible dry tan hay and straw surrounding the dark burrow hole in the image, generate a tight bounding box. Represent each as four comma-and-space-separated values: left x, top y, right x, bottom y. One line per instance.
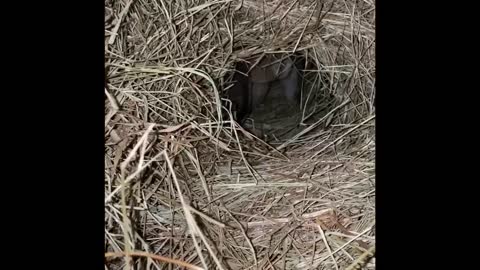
105, 0, 375, 269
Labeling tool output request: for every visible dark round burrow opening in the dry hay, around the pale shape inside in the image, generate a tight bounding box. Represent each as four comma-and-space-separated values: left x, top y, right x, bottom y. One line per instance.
222, 55, 335, 145
